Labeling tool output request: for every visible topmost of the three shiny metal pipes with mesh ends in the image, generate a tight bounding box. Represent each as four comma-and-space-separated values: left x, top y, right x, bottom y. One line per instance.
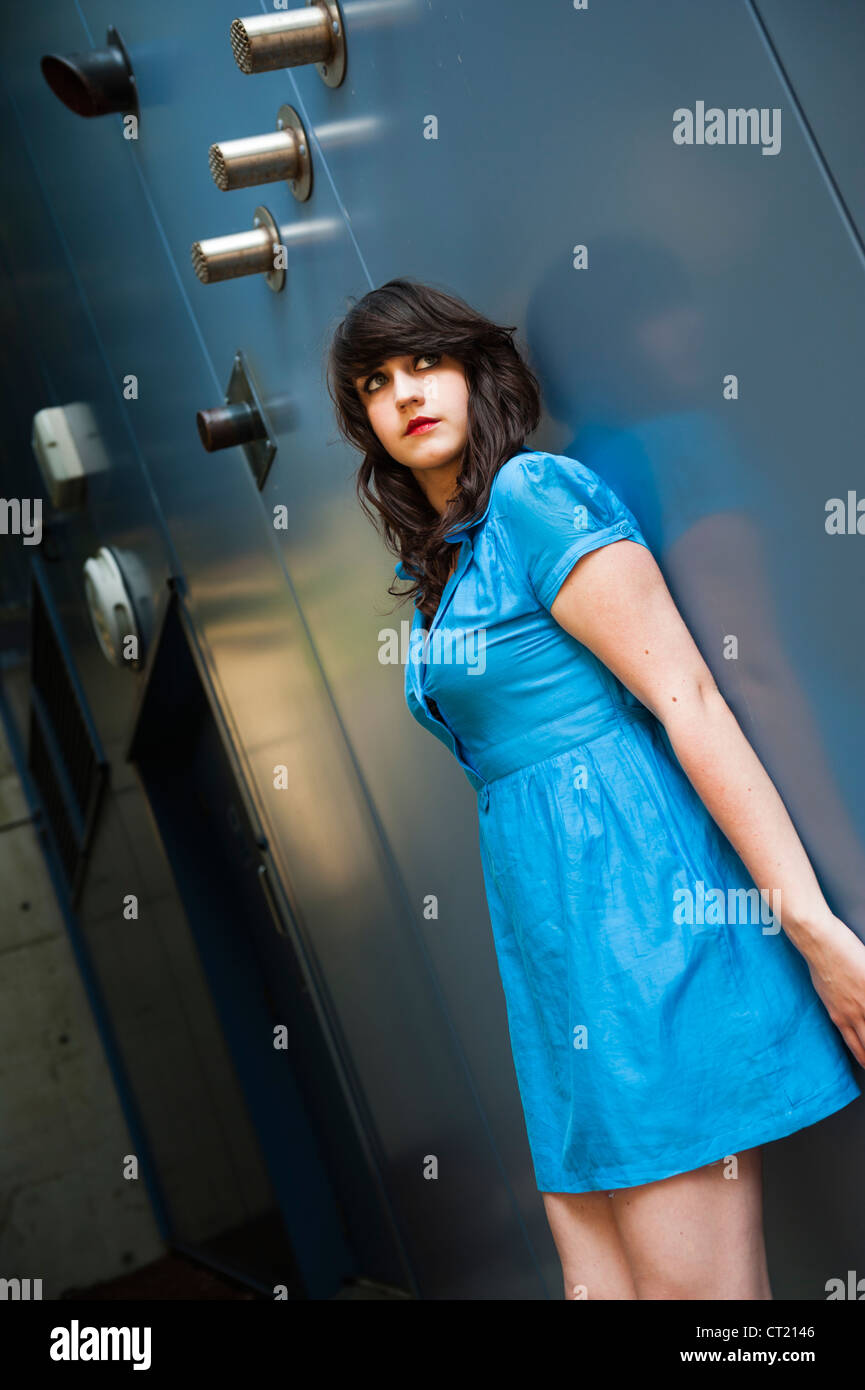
229, 0, 346, 86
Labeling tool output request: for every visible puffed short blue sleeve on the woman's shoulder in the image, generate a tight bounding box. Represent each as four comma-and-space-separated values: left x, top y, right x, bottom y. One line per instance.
502, 453, 649, 609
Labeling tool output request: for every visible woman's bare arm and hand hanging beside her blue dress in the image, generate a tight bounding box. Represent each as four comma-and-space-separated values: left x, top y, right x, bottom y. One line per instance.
551, 541, 865, 1066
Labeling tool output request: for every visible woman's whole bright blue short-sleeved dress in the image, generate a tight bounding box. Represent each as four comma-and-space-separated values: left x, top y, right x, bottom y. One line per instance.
396, 452, 861, 1193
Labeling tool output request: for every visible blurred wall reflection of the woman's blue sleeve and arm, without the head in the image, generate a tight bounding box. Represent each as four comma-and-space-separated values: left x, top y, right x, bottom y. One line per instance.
578, 409, 865, 931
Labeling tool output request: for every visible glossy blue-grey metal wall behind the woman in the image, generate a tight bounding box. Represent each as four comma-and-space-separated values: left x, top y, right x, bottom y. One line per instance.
0, 0, 865, 1298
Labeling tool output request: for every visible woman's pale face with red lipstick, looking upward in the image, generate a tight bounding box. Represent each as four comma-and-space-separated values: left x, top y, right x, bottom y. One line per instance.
355, 353, 469, 477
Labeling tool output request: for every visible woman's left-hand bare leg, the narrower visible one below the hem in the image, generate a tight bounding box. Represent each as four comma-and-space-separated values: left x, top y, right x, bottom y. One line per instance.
541, 1193, 637, 1300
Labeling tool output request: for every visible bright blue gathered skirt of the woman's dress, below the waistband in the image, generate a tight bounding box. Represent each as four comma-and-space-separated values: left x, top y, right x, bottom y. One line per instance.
478, 712, 861, 1193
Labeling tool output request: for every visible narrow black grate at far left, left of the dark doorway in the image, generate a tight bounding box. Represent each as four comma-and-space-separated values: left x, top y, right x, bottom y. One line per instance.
28, 574, 106, 902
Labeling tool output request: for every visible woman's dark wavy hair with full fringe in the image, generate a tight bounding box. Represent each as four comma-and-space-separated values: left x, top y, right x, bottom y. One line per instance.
327, 278, 541, 617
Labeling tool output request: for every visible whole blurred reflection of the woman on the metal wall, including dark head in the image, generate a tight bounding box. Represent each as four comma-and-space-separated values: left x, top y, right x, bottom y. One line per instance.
526, 232, 865, 931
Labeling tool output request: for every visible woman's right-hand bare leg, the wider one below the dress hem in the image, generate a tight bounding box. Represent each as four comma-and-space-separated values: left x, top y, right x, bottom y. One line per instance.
609, 1147, 772, 1300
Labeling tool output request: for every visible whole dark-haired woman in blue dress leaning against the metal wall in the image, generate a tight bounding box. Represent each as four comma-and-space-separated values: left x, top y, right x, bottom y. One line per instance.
328, 281, 865, 1298
